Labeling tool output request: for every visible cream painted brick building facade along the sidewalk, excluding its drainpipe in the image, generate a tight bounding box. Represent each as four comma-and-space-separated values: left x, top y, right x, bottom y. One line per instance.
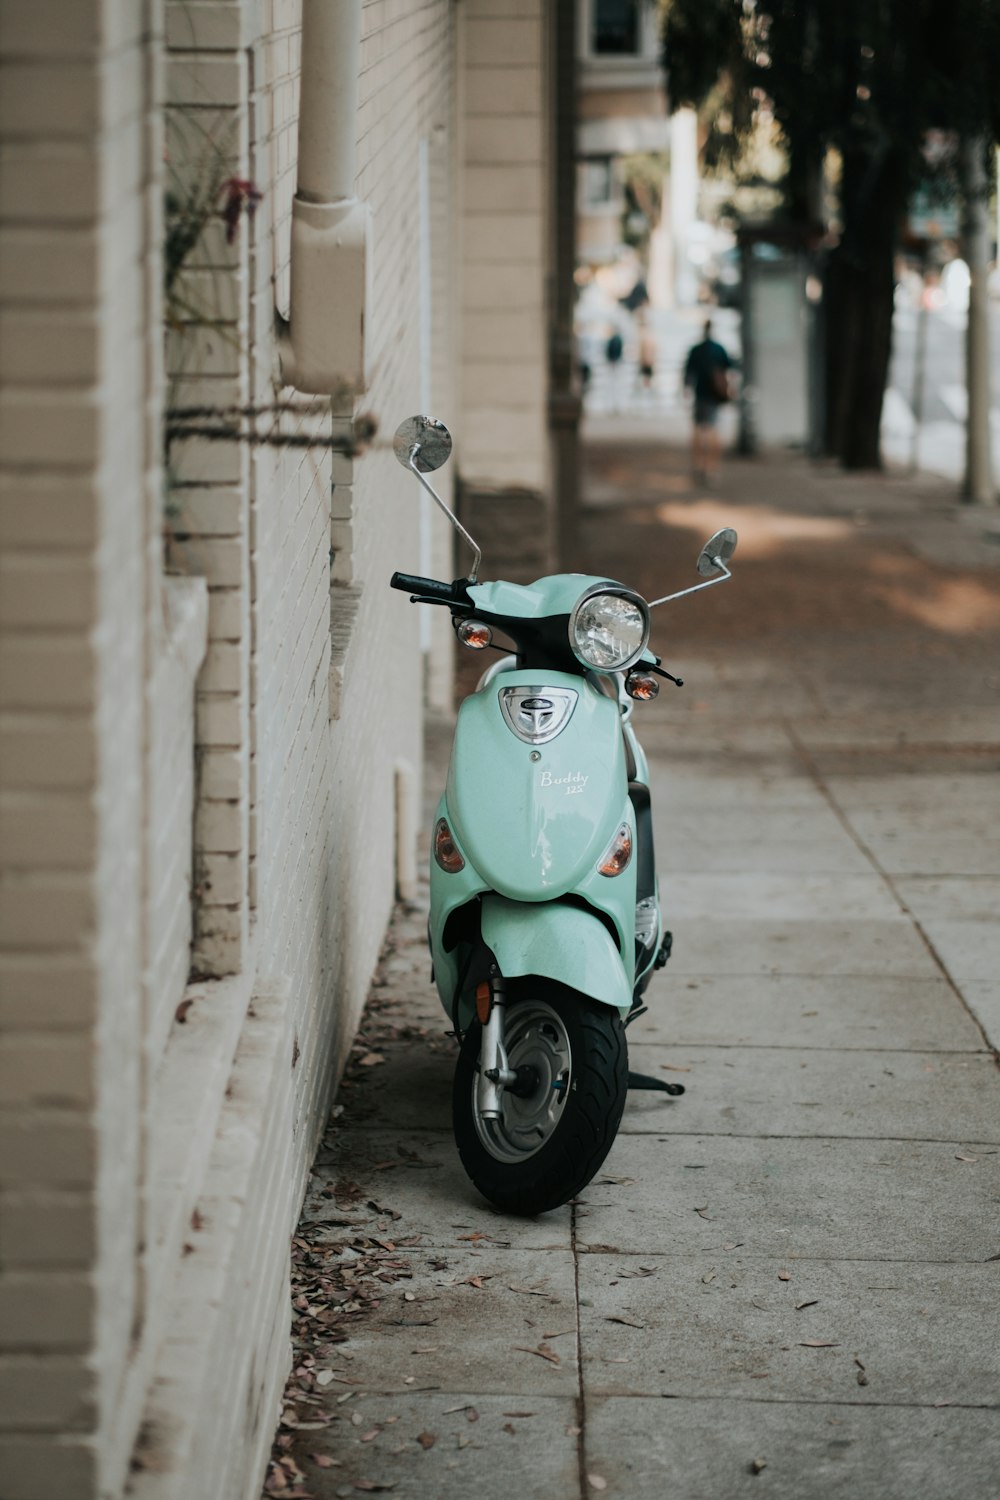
0, 0, 571, 1500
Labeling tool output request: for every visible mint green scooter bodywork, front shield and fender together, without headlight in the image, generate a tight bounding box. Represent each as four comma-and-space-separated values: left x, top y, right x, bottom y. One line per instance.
430, 669, 636, 1023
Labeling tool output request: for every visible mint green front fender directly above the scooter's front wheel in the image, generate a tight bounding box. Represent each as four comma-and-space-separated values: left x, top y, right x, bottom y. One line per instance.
481, 894, 633, 1016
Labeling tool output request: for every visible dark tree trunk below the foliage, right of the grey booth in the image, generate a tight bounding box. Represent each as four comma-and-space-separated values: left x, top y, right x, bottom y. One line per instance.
825, 141, 906, 470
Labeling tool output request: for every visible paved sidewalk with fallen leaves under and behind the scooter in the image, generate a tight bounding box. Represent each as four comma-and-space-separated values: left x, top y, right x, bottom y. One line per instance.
268, 423, 1000, 1500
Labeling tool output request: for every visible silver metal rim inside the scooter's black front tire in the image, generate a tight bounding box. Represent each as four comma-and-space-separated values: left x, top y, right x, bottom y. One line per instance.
472, 1001, 573, 1163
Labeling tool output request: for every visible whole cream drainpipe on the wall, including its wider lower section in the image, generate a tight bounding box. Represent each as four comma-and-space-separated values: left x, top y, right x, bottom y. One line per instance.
279, 0, 370, 398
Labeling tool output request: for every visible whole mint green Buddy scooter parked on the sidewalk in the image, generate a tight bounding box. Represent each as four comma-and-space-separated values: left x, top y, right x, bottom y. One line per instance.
391, 417, 736, 1214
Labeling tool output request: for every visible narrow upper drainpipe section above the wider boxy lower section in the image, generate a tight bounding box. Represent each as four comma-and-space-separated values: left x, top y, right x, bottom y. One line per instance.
297, 0, 361, 203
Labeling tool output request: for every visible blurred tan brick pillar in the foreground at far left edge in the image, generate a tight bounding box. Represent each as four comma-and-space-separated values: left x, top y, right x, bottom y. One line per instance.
0, 0, 176, 1500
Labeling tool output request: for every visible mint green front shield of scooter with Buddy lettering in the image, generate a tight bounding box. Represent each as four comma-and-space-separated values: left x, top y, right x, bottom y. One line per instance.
447, 669, 628, 902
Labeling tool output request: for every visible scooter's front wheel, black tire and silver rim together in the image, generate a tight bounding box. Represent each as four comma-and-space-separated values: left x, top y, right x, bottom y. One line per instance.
451, 980, 628, 1214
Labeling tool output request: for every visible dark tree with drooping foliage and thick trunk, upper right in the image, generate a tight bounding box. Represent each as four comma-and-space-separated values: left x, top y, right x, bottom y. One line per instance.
663, 0, 1000, 468
